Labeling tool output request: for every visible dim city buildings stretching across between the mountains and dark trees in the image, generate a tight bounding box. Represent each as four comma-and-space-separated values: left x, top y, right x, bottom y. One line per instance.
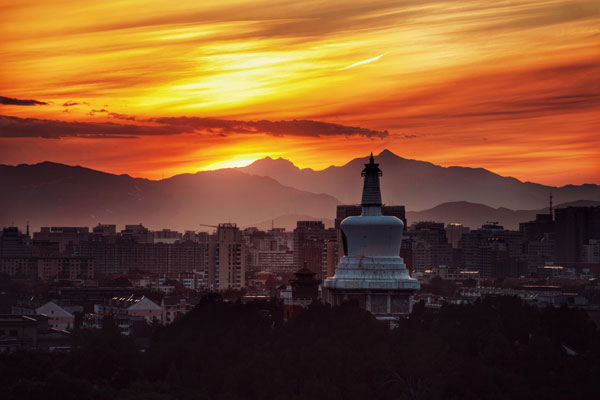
0, 205, 600, 351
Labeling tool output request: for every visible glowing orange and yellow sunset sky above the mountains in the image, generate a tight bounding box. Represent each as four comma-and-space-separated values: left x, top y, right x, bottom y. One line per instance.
0, 0, 600, 186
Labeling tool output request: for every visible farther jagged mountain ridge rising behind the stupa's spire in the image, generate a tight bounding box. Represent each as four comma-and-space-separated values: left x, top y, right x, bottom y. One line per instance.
239, 150, 600, 210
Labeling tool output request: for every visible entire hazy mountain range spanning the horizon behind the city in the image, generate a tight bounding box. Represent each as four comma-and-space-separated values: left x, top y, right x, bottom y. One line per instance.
0, 150, 600, 231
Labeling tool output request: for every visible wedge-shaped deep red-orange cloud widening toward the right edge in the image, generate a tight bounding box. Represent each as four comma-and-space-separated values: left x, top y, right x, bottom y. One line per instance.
314, 59, 600, 130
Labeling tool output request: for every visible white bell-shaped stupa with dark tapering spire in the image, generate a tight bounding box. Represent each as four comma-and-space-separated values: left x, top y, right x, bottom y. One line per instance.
324, 153, 420, 321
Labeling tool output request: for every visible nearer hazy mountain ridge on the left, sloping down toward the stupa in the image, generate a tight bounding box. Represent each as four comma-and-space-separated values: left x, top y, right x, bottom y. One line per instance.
0, 162, 339, 230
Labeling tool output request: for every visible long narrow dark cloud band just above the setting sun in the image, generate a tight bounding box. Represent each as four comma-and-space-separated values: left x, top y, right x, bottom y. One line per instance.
0, 115, 388, 139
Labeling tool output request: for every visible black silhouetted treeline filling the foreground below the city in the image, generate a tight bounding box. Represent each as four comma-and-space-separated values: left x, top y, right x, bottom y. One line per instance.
0, 297, 600, 400
